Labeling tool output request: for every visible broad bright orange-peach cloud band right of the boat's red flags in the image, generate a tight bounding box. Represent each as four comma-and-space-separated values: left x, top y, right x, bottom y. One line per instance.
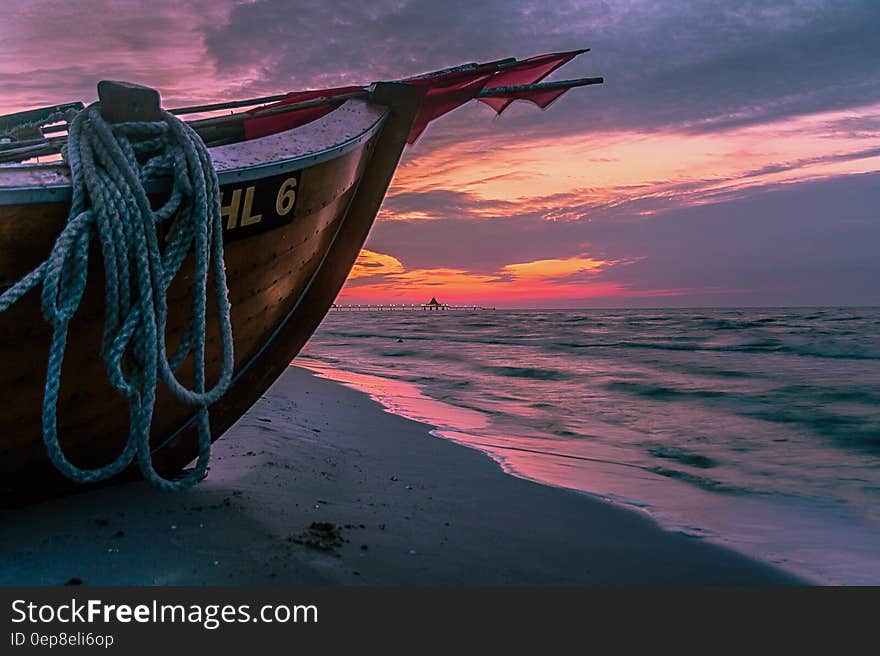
390, 104, 880, 220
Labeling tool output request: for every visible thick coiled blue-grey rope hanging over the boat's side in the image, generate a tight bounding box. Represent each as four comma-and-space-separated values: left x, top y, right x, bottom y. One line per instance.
0, 103, 233, 490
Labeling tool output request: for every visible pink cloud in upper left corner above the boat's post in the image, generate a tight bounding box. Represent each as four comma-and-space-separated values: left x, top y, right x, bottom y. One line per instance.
0, 0, 229, 111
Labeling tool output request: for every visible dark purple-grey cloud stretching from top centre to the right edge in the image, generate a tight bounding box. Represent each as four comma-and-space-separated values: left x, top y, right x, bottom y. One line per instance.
199, 0, 880, 135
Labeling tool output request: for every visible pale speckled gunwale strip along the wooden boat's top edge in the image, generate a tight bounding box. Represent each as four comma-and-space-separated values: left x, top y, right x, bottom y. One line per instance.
0, 99, 389, 207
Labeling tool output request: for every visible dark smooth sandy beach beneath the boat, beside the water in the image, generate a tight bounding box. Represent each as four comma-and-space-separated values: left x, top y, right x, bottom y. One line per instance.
0, 367, 802, 586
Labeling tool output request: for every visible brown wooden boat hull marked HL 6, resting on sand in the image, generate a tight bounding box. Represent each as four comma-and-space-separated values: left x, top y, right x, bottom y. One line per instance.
0, 53, 600, 505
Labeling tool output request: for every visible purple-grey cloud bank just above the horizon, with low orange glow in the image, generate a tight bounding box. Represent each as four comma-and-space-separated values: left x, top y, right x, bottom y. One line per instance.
356, 173, 880, 306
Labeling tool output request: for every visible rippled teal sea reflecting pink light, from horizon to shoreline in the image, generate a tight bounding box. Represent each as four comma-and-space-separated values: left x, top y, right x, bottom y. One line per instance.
294, 308, 880, 584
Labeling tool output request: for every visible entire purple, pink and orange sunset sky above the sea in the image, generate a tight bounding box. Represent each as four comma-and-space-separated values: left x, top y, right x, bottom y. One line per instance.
0, 0, 880, 307
